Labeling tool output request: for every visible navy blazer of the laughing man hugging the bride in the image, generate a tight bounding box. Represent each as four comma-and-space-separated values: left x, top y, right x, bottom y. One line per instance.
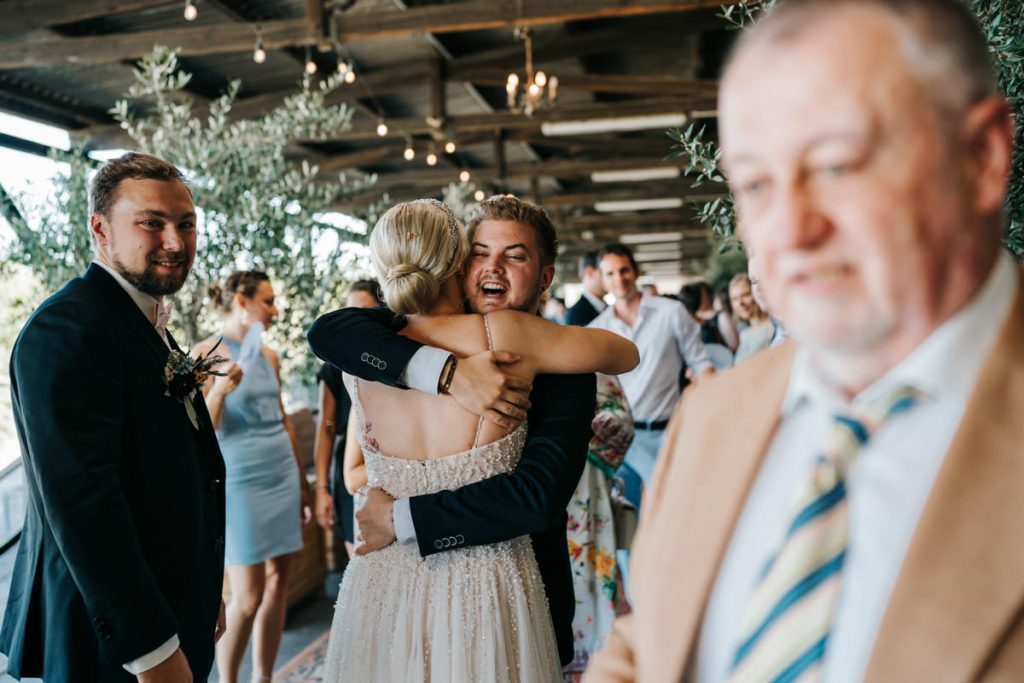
308, 308, 597, 665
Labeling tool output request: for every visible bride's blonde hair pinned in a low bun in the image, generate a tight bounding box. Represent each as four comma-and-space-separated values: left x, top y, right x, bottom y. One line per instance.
370, 200, 469, 315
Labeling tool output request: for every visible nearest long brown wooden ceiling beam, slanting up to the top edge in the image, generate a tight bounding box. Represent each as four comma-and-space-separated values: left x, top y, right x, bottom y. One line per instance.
0, 0, 737, 69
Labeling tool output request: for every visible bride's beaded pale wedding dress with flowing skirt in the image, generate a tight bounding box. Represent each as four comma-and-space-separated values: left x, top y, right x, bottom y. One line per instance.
323, 385, 562, 683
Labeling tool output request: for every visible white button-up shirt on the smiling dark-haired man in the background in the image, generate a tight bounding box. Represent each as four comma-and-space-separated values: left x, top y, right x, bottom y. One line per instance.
587, 294, 712, 422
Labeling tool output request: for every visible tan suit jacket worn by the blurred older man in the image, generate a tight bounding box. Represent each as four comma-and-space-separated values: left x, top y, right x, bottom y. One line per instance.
584, 284, 1024, 683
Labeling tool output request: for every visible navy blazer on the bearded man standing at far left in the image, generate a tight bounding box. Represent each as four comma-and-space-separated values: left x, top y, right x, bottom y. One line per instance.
0, 264, 224, 683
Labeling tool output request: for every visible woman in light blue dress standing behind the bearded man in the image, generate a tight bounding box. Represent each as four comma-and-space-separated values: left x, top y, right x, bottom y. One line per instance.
196, 270, 311, 683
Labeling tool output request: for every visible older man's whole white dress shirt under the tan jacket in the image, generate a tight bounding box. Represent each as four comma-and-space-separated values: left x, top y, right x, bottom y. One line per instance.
695, 254, 1017, 683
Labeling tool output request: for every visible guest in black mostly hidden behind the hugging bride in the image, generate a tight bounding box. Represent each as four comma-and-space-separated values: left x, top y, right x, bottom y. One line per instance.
313, 280, 381, 558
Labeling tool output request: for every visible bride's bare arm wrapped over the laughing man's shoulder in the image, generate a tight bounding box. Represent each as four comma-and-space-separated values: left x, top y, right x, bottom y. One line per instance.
487, 310, 640, 375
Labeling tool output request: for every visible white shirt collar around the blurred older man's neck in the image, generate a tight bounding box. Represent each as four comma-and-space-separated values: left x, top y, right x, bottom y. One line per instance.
782, 252, 1017, 417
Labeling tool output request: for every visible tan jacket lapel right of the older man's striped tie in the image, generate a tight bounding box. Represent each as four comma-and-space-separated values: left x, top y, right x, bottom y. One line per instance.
865, 282, 1024, 681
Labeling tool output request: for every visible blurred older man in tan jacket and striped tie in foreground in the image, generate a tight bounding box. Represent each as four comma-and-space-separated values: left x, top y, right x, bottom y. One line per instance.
589, 0, 1024, 683
